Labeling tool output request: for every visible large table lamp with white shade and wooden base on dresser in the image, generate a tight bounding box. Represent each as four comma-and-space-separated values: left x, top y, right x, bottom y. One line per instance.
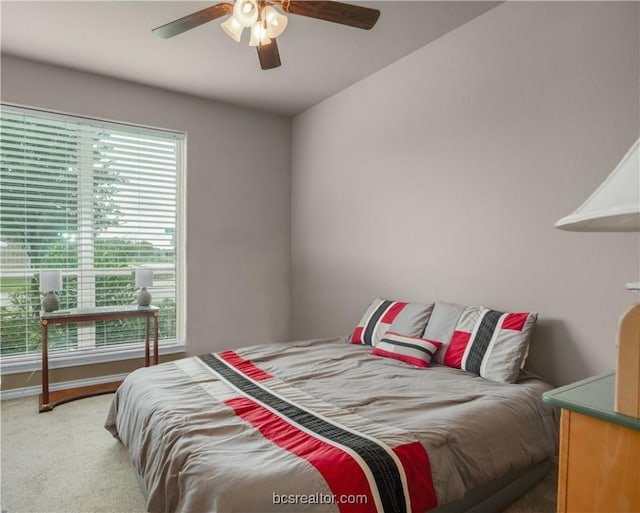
555, 139, 640, 418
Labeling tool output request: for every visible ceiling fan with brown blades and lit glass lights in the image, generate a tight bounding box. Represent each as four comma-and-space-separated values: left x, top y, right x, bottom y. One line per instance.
152, 0, 380, 69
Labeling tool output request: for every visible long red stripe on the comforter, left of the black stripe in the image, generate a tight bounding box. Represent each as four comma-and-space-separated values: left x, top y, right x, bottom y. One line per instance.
225, 398, 377, 513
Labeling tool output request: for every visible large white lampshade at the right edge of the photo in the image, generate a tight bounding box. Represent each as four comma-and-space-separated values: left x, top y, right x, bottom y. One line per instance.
555, 139, 640, 232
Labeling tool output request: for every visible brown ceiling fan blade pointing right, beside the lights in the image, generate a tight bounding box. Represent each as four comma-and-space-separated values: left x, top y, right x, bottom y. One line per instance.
281, 0, 380, 30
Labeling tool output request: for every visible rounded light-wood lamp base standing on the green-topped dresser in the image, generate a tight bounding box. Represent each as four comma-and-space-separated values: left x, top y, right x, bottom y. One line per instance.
614, 303, 640, 418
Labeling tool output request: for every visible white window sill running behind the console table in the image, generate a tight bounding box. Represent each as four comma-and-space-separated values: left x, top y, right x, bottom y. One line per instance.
0, 343, 186, 375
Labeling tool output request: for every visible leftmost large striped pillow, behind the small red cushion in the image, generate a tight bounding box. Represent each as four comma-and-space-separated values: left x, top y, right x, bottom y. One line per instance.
350, 298, 433, 346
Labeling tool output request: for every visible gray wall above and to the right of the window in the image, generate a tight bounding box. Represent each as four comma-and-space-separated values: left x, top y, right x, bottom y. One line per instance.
2, 56, 291, 354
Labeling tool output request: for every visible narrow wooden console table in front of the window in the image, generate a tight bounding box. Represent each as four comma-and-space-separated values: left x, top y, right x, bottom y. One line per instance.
40, 305, 159, 413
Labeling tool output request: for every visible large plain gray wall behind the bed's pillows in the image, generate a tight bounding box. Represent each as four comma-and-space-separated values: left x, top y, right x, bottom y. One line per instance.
292, 2, 640, 384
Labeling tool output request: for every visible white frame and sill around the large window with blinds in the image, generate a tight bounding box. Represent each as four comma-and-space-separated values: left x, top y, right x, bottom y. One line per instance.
0, 102, 188, 375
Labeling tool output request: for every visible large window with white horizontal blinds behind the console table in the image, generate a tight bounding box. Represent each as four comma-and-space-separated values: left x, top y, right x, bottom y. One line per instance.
0, 105, 185, 364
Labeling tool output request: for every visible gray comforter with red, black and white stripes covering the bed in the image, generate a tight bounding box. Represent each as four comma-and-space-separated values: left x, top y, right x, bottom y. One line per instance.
105, 338, 558, 513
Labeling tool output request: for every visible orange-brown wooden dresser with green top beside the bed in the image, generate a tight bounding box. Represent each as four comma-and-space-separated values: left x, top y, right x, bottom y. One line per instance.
543, 372, 640, 513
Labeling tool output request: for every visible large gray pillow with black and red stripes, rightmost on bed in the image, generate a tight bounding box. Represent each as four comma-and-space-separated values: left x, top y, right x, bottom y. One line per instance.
424, 302, 538, 383
